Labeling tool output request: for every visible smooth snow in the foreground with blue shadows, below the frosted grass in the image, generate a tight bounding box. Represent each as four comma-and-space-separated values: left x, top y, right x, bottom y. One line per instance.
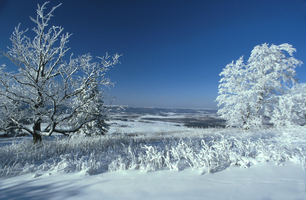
0, 162, 306, 200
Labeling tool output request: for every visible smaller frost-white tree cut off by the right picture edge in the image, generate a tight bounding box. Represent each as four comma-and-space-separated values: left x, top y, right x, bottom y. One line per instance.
271, 83, 306, 126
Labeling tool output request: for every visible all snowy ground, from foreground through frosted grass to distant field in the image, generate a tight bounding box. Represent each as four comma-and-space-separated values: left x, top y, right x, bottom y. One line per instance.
0, 108, 306, 200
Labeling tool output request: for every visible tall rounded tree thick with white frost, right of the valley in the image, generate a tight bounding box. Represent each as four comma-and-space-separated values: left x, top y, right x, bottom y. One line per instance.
216, 43, 302, 129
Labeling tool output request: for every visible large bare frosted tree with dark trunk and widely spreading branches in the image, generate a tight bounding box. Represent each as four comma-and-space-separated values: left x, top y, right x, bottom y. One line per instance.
0, 2, 120, 143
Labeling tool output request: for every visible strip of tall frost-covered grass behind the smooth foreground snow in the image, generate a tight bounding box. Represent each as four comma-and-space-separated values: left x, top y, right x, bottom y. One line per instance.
0, 126, 306, 178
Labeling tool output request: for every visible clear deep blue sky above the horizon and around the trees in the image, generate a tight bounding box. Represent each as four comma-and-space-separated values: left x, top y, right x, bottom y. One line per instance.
0, 0, 306, 108
